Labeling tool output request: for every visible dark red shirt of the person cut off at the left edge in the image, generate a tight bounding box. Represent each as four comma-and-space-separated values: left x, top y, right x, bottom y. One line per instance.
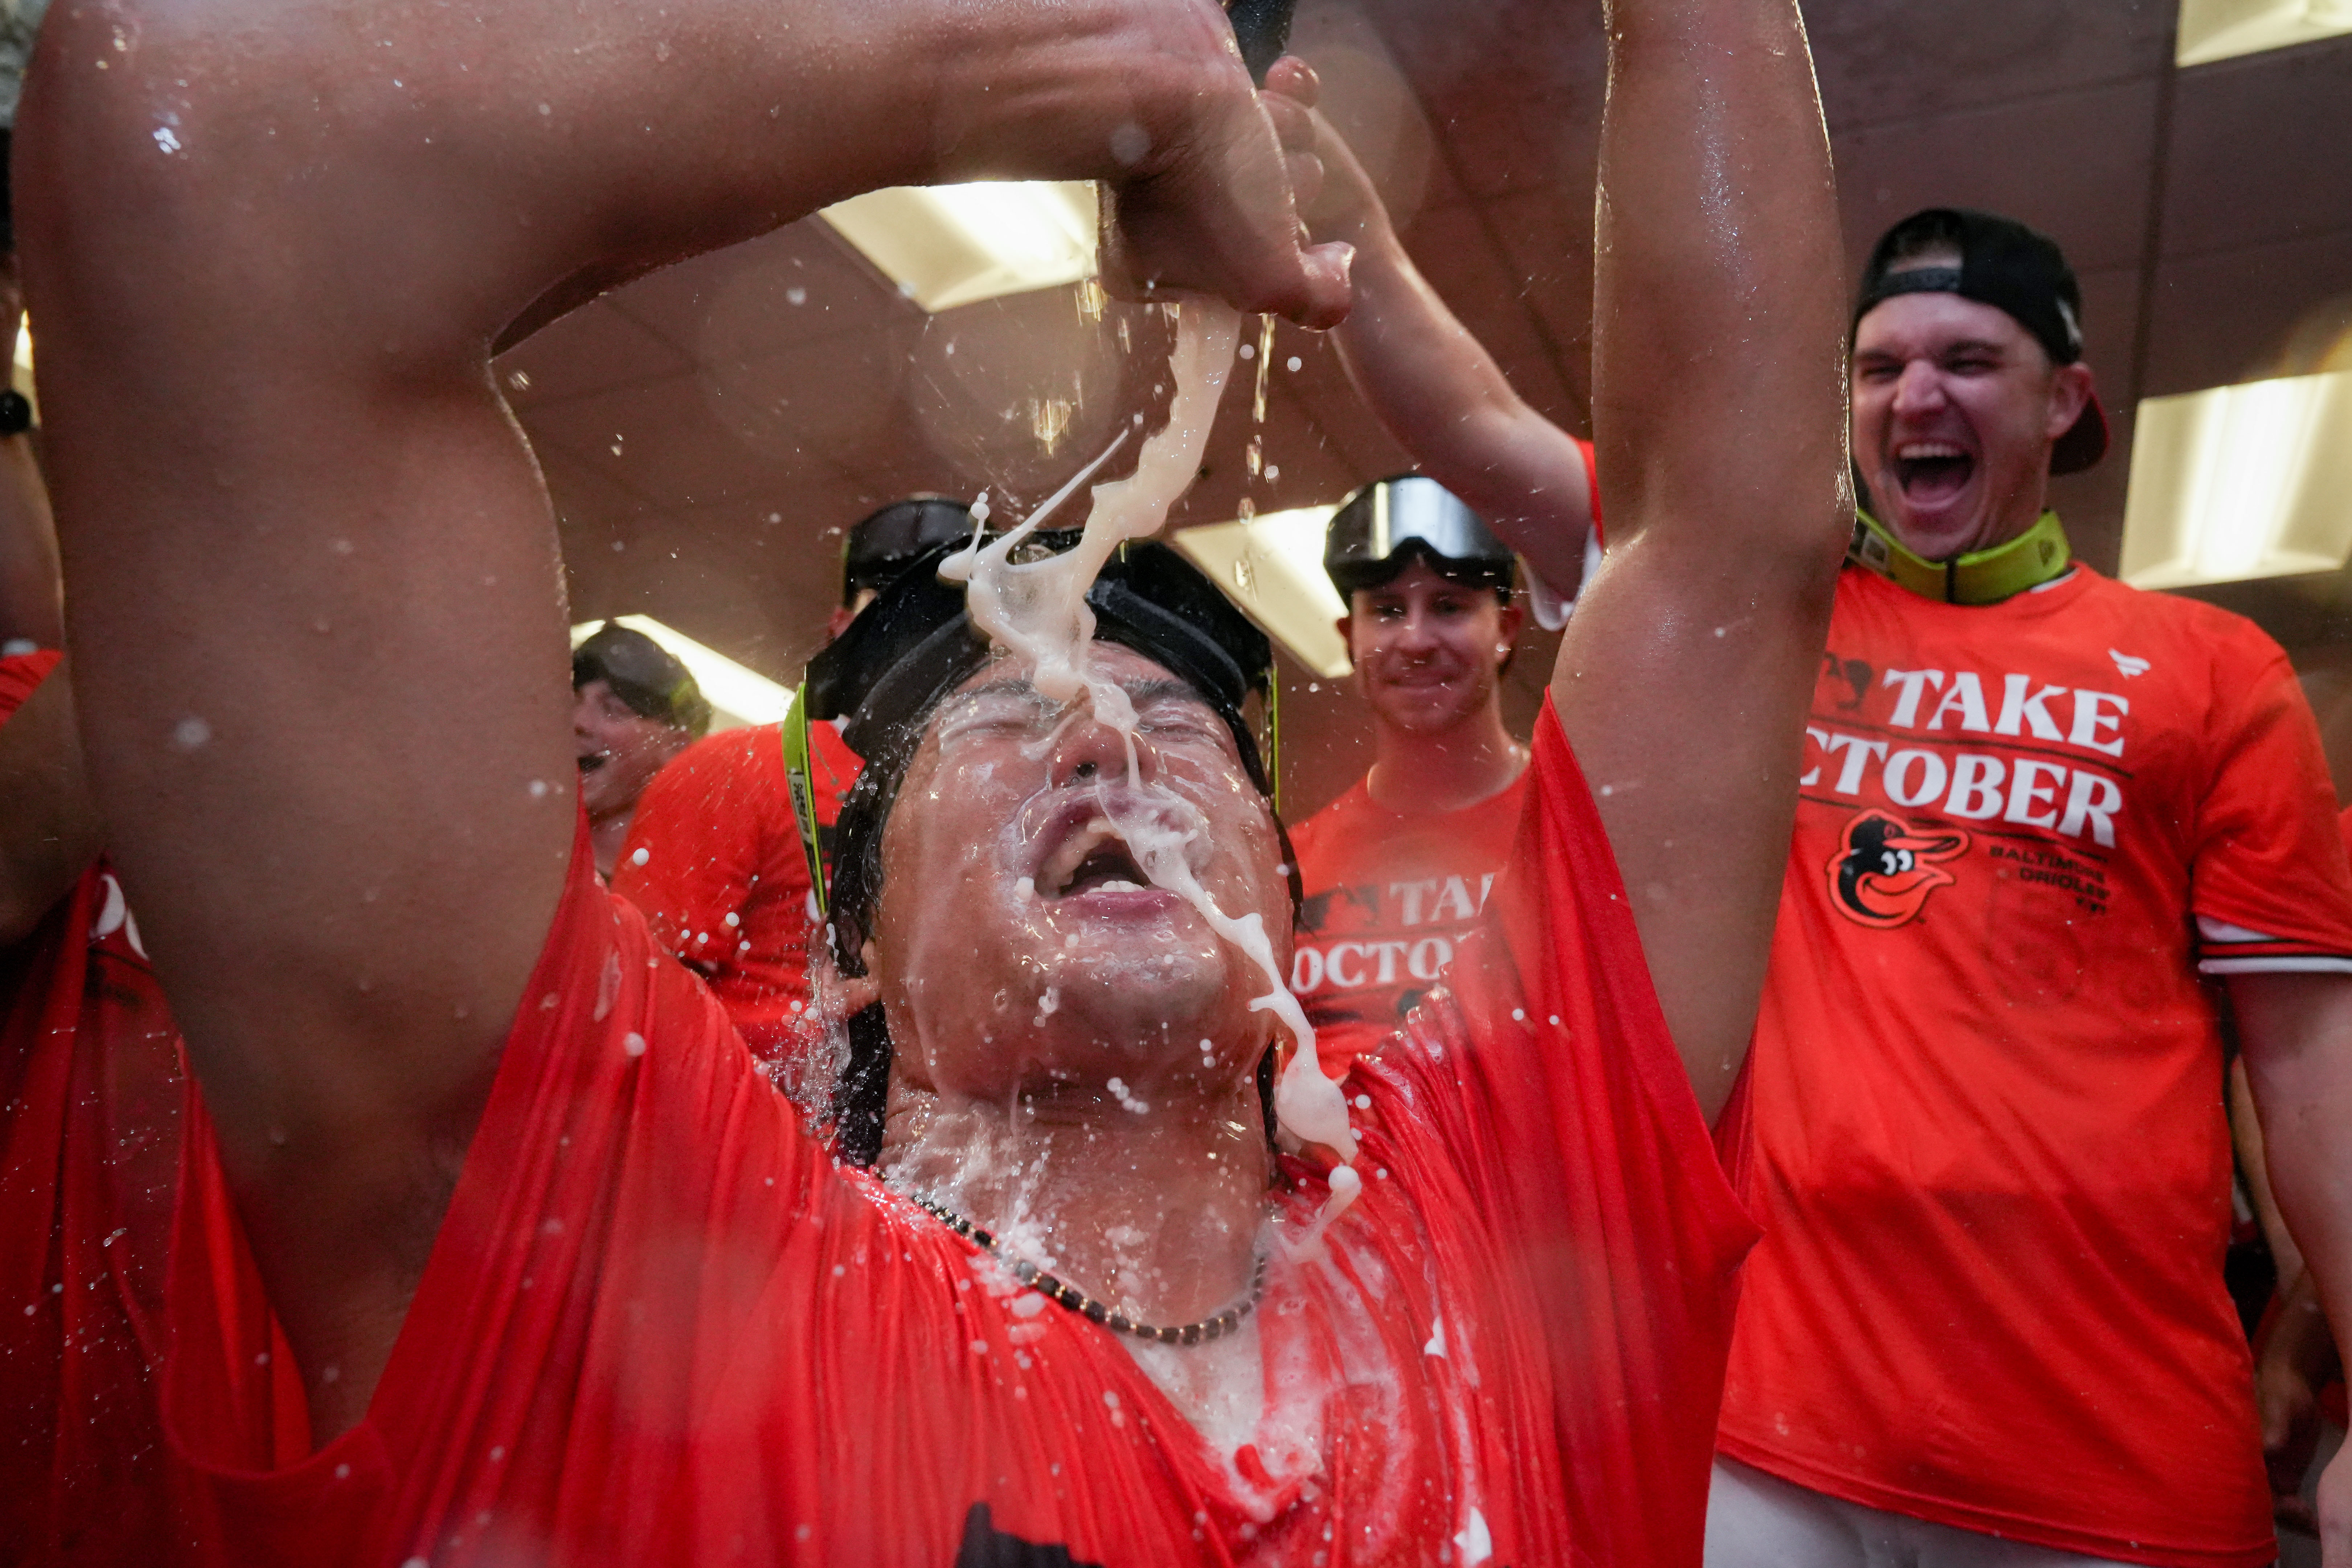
0, 651, 181, 1566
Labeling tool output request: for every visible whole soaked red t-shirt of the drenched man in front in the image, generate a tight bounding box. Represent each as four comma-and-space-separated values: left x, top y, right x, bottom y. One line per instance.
147, 717, 1755, 1568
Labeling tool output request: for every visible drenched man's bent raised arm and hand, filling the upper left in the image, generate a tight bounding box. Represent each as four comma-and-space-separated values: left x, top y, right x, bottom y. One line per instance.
16, 0, 1345, 1434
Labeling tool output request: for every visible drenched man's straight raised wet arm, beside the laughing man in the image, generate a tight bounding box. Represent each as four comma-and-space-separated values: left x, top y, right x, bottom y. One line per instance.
1552, 0, 1853, 1114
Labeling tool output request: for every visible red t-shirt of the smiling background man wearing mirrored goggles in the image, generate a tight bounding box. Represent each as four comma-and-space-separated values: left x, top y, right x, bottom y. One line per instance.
1291, 771, 1527, 1072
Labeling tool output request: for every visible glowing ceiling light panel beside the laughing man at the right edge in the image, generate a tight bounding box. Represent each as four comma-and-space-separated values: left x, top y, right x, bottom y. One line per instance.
2122, 372, 2352, 588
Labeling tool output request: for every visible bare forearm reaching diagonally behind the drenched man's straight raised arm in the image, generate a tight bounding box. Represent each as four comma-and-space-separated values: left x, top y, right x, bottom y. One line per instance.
1331, 233, 1592, 593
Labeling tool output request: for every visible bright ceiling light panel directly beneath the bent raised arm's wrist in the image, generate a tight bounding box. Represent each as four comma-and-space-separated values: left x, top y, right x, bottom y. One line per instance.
823, 181, 1096, 313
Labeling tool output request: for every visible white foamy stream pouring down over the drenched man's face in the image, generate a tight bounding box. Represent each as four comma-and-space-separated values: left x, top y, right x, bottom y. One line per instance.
938, 299, 1362, 1203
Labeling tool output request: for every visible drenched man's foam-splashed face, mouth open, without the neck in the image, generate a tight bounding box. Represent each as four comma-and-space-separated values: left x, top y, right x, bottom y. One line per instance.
870, 644, 1289, 1123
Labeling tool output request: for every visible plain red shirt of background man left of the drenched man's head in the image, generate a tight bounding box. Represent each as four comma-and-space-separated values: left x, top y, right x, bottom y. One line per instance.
611, 726, 807, 980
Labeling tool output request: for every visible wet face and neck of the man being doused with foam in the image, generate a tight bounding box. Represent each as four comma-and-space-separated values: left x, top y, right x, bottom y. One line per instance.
861, 644, 1291, 1323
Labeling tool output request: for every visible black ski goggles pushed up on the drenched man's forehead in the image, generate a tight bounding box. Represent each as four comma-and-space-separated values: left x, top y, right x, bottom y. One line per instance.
783, 531, 1282, 919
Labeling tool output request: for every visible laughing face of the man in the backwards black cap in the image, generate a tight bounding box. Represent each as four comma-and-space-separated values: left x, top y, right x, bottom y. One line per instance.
1853, 286, 2091, 562
